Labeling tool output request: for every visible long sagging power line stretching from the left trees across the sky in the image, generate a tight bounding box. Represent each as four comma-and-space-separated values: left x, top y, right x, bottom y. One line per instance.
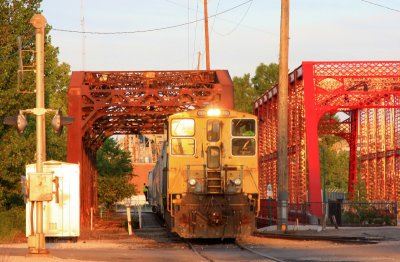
53, 0, 253, 35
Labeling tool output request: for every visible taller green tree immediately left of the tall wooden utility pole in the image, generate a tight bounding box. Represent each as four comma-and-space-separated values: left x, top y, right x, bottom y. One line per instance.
251, 63, 279, 97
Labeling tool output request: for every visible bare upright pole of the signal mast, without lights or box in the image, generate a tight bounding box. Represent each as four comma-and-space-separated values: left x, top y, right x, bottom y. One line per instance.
28, 14, 48, 254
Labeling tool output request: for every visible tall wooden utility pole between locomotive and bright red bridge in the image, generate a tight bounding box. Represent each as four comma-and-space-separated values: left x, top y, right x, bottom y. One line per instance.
278, 0, 289, 231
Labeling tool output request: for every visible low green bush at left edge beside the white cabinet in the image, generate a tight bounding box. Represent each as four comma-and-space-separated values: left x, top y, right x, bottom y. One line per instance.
0, 207, 25, 242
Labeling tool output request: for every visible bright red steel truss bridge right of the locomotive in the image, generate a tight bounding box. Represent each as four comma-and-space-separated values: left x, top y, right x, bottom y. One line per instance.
254, 61, 400, 217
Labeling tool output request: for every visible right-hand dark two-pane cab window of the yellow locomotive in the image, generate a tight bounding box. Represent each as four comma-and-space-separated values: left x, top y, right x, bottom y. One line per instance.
232, 119, 256, 156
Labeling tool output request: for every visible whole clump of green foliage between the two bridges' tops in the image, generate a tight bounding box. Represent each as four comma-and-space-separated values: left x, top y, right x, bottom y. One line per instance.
233, 63, 279, 113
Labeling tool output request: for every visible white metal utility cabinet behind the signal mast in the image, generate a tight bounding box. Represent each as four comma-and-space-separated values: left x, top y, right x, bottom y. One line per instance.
26, 161, 80, 237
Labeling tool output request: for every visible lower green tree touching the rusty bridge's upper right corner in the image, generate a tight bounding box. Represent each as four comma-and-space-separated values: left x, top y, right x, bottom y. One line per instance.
233, 74, 256, 113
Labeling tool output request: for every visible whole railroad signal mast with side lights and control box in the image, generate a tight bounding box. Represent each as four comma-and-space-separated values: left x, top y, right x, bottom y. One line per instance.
3, 14, 74, 255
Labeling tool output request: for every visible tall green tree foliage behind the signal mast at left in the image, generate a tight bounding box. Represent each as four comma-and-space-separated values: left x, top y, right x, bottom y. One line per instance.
0, 0, 70, 210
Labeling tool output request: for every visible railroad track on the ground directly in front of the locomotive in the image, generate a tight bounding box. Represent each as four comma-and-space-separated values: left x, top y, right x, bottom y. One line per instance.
187, 240, 285, 262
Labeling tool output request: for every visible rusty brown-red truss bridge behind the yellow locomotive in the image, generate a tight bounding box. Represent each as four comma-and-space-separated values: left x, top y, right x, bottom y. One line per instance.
67, 70, 233, 227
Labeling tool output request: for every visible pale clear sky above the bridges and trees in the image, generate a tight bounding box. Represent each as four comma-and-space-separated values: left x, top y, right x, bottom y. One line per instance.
41, 0, 400, 77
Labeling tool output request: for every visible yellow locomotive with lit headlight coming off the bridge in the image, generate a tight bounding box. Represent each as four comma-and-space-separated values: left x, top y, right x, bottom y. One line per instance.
149, 108, 259, 238
